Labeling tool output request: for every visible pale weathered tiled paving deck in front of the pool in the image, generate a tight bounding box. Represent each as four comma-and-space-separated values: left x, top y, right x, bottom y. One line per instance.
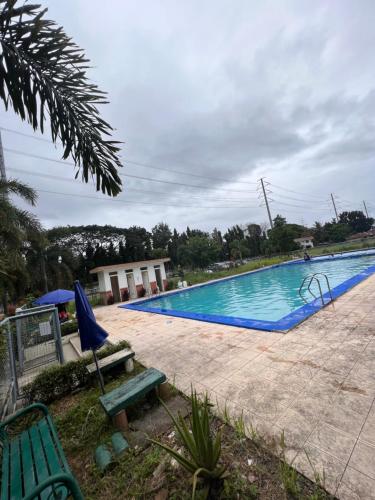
95, 276, 375, 500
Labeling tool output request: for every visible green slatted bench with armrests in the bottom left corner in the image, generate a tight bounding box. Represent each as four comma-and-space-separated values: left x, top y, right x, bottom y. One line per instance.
0, 403, 83, 500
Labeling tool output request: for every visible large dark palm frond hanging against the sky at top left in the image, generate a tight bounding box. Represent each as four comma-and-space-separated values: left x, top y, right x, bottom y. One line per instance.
0, 0, 121, 196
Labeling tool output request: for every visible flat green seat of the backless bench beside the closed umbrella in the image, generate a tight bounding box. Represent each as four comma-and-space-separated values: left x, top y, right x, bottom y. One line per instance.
99, 368, 166, 417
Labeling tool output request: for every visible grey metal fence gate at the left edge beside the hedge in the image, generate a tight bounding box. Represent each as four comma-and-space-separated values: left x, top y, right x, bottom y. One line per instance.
0, 306, 64, 412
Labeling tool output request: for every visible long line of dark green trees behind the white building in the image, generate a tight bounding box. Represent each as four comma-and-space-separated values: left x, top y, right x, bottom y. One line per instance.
3, 211, 374, 306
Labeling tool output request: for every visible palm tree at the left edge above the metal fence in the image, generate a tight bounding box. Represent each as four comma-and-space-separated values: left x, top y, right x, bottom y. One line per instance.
0, 179, 41, 310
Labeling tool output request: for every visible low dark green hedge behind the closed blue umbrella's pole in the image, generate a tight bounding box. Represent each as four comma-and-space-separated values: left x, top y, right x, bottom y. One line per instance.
24, 340, 130, 404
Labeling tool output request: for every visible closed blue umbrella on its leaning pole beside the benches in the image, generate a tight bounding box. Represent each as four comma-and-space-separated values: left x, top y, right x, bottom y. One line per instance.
74, 281, 108, 394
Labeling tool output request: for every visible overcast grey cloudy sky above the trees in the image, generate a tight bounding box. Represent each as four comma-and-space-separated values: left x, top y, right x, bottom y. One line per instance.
0, 0, 375, 230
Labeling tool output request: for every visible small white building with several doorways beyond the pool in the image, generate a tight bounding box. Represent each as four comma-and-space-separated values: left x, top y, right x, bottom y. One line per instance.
90, 258, 171, 304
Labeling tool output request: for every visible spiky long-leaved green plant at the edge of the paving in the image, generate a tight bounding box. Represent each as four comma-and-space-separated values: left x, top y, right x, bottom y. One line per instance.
151, 389, 227, 499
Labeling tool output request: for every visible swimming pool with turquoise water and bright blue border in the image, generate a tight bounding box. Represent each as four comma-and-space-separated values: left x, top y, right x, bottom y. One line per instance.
120, 251, 375, 331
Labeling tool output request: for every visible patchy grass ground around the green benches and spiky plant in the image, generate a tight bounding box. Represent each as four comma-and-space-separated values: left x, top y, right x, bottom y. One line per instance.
41, 370, 338, 500
